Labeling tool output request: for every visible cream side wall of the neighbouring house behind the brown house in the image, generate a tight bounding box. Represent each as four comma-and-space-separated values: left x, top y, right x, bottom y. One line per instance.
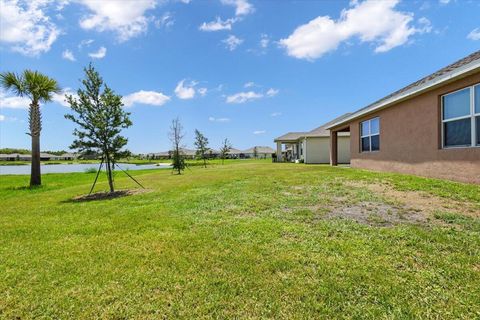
304, 136, 350, 163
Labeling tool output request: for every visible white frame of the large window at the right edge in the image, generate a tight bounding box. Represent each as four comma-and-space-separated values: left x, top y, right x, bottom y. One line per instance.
440, 83, 480, 149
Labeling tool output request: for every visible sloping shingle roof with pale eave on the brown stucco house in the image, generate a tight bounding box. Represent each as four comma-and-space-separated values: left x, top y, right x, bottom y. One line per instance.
327, 50, 480, 129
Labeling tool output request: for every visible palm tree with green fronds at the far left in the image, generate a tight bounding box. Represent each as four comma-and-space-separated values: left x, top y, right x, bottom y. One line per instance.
0, 70, 60, 187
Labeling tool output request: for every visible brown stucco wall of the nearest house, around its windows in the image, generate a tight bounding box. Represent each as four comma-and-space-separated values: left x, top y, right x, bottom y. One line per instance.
333, 73, 480, 183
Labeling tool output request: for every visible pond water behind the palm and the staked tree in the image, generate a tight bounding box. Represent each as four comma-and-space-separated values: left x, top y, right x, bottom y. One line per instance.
0, 163, 171, 175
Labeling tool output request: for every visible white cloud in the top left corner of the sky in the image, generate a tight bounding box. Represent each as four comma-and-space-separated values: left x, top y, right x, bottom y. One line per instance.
0, 0, 60, 56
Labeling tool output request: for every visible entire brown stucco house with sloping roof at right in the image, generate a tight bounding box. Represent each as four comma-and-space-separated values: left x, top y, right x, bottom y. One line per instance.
328, 51, 480, 183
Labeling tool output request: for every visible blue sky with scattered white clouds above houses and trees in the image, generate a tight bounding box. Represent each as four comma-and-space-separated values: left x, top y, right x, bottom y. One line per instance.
0, 0, 480, 153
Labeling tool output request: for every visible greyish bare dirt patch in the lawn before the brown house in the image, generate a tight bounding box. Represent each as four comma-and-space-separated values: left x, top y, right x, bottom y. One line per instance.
323, 202, 430, 227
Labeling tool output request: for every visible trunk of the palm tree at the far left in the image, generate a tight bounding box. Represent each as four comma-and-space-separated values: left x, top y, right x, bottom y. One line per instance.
28, 101, 42, 187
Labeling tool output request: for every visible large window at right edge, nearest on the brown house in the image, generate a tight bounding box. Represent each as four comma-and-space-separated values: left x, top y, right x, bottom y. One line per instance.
442, 85, 480, 148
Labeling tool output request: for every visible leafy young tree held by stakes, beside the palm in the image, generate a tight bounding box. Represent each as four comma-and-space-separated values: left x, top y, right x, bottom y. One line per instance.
65, 64, 132, 192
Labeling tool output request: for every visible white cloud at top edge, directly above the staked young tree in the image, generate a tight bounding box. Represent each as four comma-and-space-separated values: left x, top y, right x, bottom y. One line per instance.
80, 0, 156, 41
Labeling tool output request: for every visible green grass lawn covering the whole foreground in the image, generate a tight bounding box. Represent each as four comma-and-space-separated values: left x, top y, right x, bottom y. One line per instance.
0, 161, 480, 319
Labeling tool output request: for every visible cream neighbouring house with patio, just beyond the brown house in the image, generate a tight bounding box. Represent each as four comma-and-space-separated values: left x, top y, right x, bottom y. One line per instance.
274, 113, 350, 164
